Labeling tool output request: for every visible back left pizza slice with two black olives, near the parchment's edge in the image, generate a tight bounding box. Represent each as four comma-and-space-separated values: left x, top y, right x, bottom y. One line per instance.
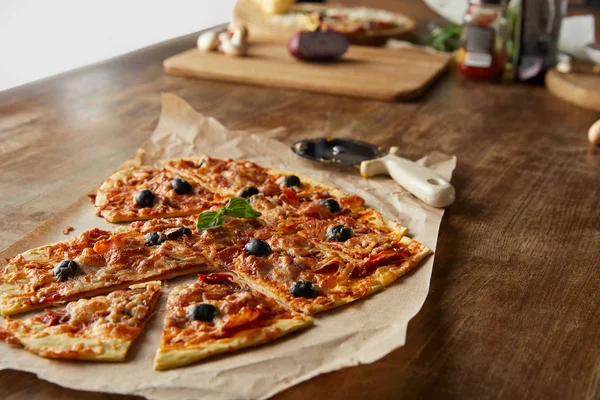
94, 166, 227, 222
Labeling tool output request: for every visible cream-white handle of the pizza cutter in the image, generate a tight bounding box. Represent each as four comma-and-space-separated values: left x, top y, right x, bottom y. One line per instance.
360, 147, 456, 207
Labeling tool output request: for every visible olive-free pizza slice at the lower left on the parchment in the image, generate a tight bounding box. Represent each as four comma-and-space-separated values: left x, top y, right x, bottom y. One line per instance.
0, 282, 161, 361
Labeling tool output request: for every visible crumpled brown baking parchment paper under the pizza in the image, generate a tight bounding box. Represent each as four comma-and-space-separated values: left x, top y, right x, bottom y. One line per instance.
0, 94, 456, 400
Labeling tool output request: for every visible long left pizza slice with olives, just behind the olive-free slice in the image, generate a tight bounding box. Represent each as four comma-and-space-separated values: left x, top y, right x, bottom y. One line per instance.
0, 225, 208, 315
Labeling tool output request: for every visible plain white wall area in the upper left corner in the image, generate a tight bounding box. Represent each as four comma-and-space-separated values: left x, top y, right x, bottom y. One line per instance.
0, 0, 235, 90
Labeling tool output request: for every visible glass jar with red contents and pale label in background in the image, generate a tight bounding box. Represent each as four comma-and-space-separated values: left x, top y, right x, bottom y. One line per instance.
458, 0, 508, 81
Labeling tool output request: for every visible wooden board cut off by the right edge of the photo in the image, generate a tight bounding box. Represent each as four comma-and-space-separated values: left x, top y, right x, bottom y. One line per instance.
546, 68, 600, 112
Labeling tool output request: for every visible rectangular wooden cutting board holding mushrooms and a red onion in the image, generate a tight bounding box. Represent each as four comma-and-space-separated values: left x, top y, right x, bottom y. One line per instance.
164, 43, 450, 101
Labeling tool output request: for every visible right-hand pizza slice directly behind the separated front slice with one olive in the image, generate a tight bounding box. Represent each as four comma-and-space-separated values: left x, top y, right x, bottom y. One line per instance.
227, 221, 431, 314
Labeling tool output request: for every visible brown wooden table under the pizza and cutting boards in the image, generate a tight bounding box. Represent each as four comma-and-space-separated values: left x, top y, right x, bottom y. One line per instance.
0, 0, 600, 400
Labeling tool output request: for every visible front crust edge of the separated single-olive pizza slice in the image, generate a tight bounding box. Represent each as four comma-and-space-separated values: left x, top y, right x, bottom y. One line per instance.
154, 316, 313, 371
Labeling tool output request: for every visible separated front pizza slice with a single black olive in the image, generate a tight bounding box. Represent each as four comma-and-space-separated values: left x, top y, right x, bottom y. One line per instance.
154, 273, 313, 370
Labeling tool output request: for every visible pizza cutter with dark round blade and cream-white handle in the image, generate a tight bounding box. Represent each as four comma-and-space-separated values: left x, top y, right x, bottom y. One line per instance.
292, 138, 455, 207
